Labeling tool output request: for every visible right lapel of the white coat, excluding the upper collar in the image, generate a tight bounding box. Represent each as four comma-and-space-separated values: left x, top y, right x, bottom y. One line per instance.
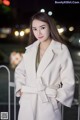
37, 40, 54, 76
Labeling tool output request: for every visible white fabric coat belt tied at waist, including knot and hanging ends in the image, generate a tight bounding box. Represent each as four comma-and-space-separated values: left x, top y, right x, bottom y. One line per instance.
21, 86, 58, 109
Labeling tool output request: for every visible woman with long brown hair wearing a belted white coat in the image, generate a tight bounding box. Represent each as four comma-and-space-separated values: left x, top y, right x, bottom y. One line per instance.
15, 13, 75, 120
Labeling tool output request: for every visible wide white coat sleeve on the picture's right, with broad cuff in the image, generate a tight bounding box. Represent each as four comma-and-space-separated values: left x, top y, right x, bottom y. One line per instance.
56, 45, 75, 107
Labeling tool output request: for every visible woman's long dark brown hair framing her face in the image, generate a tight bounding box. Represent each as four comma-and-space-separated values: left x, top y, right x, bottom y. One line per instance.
29, 12, 64, 44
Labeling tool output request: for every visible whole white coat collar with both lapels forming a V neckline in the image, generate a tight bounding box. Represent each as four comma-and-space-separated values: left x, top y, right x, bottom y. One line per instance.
24, 40, 61, 77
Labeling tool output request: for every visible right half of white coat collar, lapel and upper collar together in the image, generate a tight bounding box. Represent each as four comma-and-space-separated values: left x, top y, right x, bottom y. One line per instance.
37, 40, 61, 76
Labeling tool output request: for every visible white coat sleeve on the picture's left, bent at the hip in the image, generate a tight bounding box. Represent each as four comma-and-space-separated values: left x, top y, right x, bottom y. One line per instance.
14, 55, 26, 97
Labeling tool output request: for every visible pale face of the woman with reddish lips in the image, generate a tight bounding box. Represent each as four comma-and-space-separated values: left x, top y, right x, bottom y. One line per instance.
32, 19, 50, 42
